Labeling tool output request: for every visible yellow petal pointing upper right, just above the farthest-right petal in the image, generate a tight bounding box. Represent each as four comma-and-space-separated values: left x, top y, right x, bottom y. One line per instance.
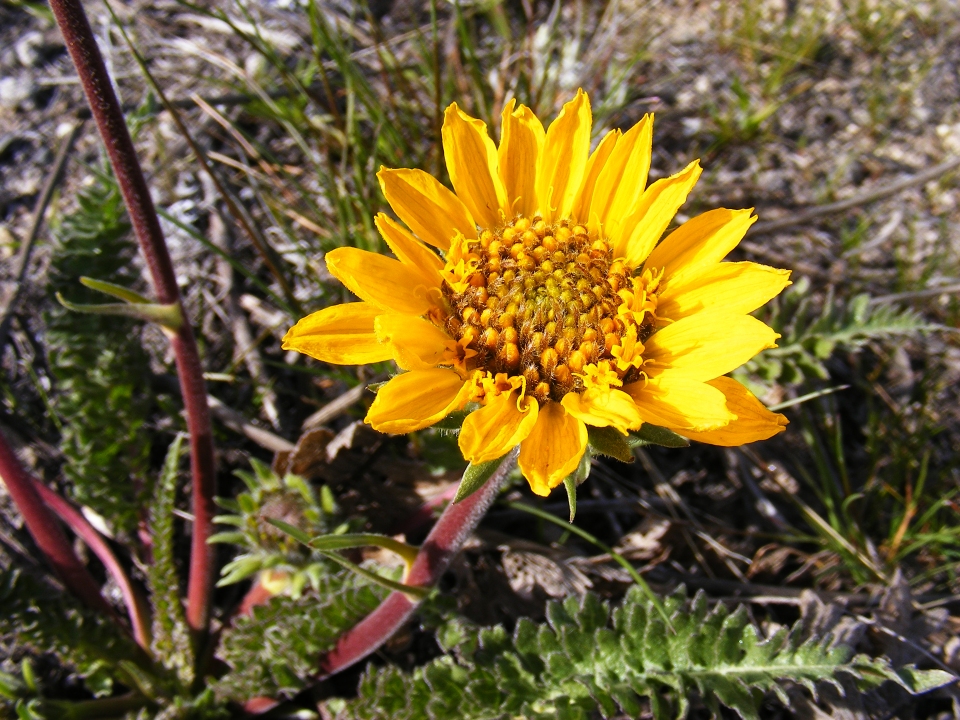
644, 208, 757, 284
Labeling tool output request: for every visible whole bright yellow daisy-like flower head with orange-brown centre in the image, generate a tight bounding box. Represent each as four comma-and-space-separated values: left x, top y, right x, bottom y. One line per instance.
283, 91, 789, 495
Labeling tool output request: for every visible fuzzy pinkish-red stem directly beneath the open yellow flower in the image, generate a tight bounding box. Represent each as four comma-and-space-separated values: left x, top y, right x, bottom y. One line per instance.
321, 450, 518, 677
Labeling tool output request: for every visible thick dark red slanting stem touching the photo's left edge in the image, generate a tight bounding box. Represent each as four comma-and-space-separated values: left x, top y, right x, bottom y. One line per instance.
0, 434, 115, 617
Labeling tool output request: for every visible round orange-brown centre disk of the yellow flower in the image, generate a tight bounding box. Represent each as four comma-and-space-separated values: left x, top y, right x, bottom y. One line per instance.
435, 216, 659, 405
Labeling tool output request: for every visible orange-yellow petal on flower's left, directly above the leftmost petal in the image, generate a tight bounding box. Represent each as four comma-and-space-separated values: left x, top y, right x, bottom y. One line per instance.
326, 248, 431, 315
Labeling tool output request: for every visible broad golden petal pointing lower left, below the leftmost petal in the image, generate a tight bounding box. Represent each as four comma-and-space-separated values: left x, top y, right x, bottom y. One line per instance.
364, 368, 470, 435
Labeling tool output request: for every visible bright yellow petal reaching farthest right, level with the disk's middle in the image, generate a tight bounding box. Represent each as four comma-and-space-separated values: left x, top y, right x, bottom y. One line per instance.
657, 262, 790, 320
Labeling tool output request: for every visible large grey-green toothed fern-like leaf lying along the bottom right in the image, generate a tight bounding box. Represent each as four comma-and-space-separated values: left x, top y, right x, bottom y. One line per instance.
331, 586, 952, 720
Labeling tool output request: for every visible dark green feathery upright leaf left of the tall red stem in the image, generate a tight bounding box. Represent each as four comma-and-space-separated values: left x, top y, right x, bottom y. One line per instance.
46, 165, 156, 533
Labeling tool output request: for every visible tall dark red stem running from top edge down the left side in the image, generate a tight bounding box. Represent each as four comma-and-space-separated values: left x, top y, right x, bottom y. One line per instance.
50, 0, 216, 633
